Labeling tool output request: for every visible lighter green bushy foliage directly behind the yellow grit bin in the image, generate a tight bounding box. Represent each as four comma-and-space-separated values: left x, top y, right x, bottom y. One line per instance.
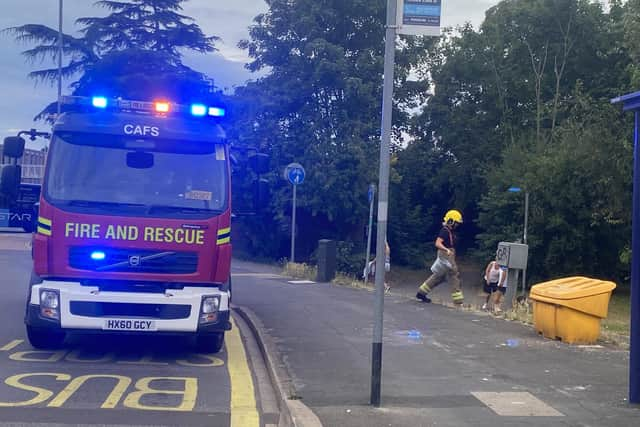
478, 94, 632, 280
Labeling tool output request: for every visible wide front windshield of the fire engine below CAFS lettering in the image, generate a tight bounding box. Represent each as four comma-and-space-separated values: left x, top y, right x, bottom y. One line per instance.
45, 132, 227, 216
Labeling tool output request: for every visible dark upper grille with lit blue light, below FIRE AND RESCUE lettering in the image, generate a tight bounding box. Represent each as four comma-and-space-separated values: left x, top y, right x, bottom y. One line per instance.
69, 246, 198, 274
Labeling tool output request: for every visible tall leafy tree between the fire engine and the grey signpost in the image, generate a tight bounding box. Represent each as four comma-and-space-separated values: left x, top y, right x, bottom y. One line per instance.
234, 0, 432, 262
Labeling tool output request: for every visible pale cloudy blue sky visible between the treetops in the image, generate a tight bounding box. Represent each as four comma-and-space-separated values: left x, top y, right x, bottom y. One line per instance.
0, 0, 498, 148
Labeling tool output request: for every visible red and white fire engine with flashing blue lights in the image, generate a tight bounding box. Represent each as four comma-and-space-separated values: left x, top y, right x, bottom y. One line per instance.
0, 97, 266, 353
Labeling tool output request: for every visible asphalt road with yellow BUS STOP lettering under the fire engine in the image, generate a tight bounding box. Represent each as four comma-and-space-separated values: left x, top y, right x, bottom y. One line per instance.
0, 233, 277, 427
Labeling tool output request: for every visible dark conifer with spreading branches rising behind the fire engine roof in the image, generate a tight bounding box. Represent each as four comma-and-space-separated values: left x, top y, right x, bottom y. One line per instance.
7, 0, 217, 118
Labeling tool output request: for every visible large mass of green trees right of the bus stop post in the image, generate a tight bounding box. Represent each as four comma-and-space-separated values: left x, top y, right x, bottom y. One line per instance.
390, 0, 640, 280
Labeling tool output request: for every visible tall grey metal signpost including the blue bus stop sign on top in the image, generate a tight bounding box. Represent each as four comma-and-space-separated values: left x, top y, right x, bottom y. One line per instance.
371, 0, 441, 407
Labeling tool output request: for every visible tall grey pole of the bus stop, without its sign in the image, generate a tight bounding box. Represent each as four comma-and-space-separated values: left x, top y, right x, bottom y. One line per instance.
371, 0, 398, 407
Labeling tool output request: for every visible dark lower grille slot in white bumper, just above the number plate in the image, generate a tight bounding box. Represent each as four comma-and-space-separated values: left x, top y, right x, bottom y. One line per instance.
70, 301, 191, 320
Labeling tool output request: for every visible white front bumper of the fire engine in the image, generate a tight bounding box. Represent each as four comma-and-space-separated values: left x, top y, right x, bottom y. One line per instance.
25, 280, 231, 335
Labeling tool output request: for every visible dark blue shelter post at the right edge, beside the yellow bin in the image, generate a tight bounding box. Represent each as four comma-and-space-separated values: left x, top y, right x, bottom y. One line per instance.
629, 110, 640, 403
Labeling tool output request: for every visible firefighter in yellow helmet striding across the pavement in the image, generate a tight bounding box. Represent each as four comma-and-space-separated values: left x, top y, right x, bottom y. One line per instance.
416, 209, 464, 304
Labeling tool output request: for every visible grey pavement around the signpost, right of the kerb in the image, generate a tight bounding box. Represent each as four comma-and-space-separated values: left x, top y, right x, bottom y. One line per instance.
233, 261, 640, 427
